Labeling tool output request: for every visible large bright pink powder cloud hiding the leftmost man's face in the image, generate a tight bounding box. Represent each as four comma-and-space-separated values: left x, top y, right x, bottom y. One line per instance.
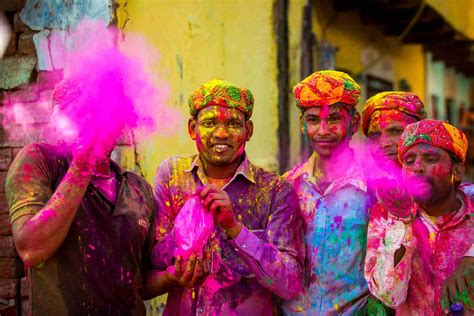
3, 21, 182, 151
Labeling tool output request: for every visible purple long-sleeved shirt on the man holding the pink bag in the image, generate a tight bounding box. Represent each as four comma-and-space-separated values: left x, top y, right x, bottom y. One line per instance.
153, 155, 304, 315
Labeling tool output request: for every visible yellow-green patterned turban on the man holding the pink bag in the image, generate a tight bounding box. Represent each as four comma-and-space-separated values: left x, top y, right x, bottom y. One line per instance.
188, 79, 254, 119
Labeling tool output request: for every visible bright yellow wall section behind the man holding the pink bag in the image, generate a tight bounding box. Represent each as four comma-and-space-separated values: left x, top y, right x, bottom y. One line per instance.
117, 0, 278, 182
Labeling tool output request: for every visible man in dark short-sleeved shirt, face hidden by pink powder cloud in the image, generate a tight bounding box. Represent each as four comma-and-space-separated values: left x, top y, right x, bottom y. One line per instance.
6, 81, 167, 315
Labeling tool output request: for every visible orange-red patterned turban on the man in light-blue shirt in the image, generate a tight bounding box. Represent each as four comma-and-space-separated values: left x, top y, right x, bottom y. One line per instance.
293, 70, 360, 108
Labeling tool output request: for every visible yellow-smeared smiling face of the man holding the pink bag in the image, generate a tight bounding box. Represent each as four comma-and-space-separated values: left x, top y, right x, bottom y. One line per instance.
188, 105, 253, 166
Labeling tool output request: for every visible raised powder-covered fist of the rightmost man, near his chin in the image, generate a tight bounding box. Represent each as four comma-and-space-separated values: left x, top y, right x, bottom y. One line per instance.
376, 180, 413, 218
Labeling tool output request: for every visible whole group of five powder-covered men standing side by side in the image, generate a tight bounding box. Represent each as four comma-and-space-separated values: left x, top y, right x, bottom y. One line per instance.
6, 70, 474, 315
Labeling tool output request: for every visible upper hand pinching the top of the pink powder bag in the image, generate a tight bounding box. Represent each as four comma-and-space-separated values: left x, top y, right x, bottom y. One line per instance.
200, 184, 242, 239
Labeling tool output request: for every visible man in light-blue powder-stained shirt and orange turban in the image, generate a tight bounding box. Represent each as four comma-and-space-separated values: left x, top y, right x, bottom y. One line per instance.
282, 70, 383, 315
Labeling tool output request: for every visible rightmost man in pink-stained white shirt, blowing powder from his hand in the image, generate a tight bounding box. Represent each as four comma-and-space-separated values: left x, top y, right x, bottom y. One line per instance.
365, 120, 474, 315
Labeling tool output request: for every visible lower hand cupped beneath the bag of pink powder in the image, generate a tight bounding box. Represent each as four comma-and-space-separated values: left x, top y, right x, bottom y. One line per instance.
167, 254, 209, 288
